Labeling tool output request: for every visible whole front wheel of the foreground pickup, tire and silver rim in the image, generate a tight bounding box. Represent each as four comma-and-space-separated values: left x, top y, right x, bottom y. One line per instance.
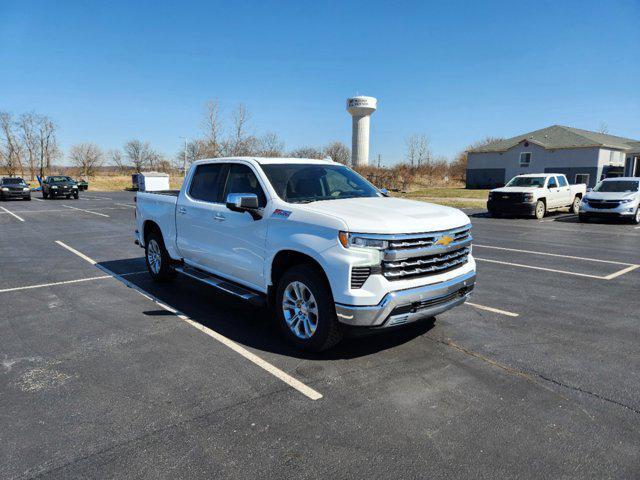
275, 265, 342, 352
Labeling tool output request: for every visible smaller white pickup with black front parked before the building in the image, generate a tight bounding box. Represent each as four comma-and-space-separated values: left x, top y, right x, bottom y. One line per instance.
487, 173, 587, 220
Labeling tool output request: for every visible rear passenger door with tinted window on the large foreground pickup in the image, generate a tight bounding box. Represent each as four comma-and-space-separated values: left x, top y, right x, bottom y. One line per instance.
175, 163, 227, 270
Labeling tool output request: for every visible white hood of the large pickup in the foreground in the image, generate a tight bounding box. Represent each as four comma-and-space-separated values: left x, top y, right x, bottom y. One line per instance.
304, 197, 471, 233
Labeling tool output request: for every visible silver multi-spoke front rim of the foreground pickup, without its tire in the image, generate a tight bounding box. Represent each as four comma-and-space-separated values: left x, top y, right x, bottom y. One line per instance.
282, 282, 319, 340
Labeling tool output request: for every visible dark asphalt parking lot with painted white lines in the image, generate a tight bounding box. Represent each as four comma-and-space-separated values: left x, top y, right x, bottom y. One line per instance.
0, 191, 640, 479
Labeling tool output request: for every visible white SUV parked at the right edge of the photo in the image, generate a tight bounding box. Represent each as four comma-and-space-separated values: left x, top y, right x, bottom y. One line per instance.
578, 177, 640, 224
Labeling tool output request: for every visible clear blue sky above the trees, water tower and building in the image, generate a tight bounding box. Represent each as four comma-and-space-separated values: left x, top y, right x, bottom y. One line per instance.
0, 0, 640, 163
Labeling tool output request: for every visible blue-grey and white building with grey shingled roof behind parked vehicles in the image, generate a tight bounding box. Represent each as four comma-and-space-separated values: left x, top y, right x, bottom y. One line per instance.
467, 125, 640, 188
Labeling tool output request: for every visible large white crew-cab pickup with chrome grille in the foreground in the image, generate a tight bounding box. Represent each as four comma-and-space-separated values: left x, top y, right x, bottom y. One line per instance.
135, 158, 476, 350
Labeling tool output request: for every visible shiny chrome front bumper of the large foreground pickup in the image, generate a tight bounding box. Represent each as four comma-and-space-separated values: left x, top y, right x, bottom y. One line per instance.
336, 271, 476, 328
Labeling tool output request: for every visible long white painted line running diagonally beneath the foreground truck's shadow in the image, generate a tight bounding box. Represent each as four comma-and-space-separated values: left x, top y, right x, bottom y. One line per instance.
55, 240, 322, 400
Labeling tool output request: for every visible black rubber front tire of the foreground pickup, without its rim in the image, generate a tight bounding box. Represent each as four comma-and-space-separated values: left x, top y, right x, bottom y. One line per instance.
274, 264, 343, 352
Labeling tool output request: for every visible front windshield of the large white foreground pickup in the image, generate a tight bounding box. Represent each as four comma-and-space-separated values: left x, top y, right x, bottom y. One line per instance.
261, 163, 381, 203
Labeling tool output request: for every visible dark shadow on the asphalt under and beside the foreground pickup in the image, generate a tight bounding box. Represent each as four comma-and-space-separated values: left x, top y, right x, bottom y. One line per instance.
98, 257, 434, 360
